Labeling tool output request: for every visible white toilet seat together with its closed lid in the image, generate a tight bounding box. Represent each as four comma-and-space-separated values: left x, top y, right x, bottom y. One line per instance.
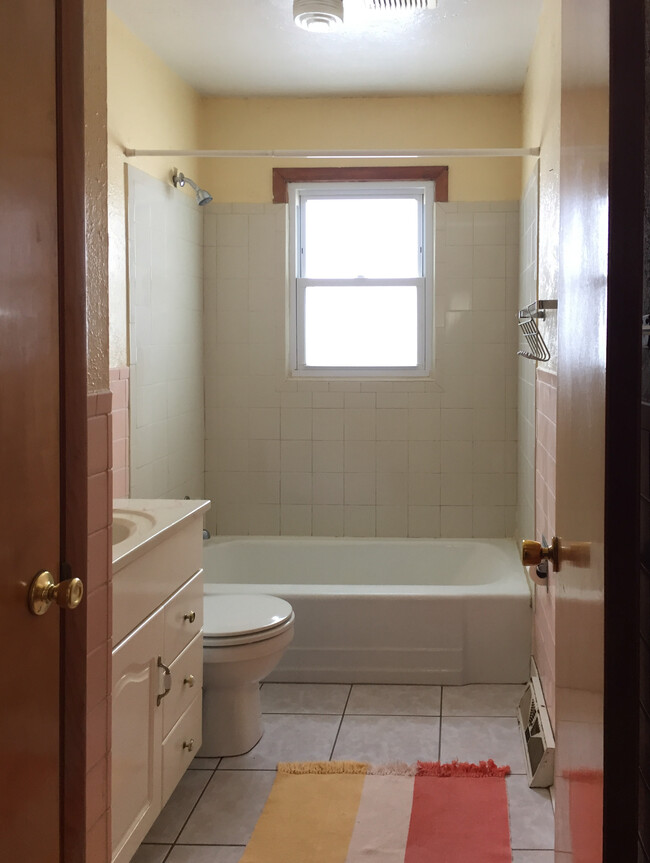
203, 593, 294, 648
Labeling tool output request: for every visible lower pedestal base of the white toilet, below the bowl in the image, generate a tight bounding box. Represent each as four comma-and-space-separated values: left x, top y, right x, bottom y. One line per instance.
201, 682, 263, 758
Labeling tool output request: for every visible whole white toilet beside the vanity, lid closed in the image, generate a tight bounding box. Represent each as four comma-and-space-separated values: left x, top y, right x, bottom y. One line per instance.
201, 593, 294, 758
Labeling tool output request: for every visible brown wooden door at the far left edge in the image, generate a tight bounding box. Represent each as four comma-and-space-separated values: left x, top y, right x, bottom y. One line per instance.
0, 0, 60, 863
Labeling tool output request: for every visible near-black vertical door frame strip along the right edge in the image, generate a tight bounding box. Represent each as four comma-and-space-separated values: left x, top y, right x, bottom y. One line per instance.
603, 0, 646, 852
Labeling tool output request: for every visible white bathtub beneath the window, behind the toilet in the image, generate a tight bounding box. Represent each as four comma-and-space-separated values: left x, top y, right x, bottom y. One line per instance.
203, 537, 531, 684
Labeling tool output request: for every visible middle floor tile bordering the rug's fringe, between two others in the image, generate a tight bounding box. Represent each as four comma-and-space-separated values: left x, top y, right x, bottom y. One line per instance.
332, 716, 439, 765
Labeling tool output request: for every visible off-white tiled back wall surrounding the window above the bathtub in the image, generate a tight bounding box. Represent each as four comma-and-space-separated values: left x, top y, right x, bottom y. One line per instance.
204, 202, 519, 537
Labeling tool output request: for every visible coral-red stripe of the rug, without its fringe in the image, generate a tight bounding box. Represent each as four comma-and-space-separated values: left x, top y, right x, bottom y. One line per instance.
404, 775, 512, 863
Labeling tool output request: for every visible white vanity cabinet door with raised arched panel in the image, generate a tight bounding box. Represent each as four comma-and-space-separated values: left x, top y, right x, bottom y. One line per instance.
111, 609, 164, 863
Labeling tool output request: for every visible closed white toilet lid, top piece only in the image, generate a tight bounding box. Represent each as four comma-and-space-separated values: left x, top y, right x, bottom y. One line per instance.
203, 593, 293, 637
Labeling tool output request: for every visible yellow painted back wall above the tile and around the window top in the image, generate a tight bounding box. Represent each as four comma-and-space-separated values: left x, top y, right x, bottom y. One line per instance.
196, 94, 521, 203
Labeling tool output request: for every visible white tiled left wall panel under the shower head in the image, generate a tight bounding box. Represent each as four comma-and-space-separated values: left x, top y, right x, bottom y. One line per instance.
128, 167, 204, 498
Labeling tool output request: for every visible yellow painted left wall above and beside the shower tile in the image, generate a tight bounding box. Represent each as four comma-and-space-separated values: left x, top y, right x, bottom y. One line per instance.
107, 12, 200, 367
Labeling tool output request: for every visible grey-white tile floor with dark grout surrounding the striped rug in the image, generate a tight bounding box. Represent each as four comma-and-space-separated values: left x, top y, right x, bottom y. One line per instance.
133, 683, 553, 863
